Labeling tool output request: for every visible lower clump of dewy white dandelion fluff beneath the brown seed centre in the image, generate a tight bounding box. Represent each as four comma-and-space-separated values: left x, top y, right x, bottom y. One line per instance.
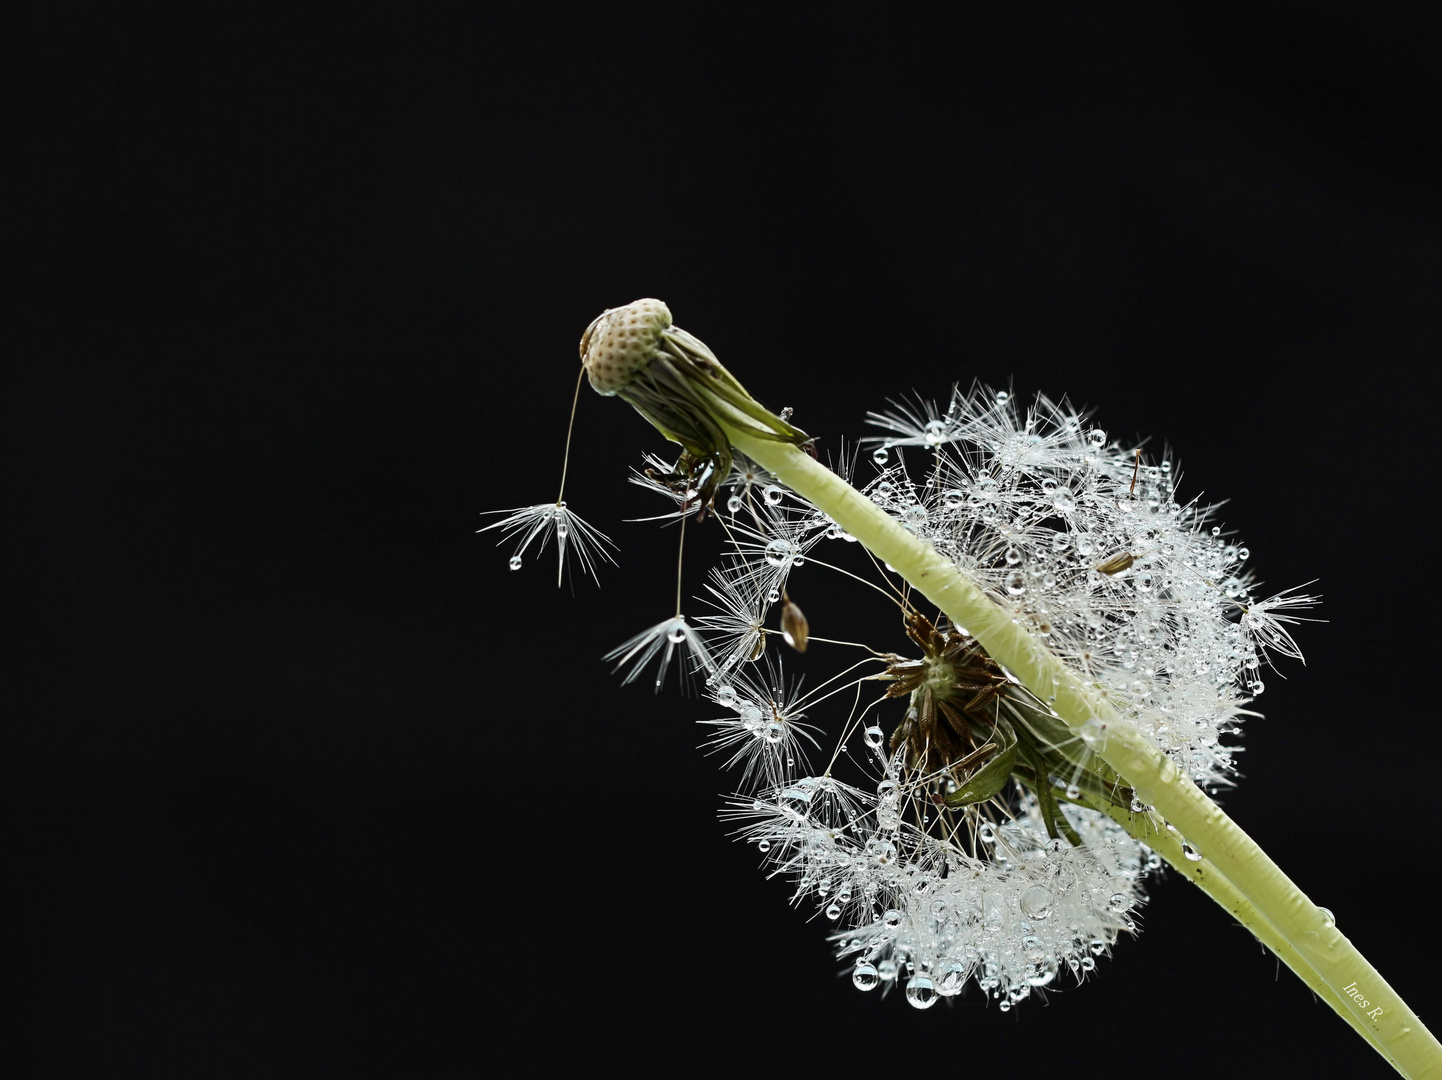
724, 744, 1159, 1009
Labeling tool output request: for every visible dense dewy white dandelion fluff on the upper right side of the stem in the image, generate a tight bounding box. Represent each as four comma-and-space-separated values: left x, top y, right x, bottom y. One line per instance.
865, 385, 1315, 789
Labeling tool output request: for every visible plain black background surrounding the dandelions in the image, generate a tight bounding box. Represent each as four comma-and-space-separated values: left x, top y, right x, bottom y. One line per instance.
14, 3, 1439, 1077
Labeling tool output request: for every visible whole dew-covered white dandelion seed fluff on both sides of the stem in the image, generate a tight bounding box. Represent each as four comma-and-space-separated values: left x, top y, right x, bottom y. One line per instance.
573, 377, 1312, 1009
